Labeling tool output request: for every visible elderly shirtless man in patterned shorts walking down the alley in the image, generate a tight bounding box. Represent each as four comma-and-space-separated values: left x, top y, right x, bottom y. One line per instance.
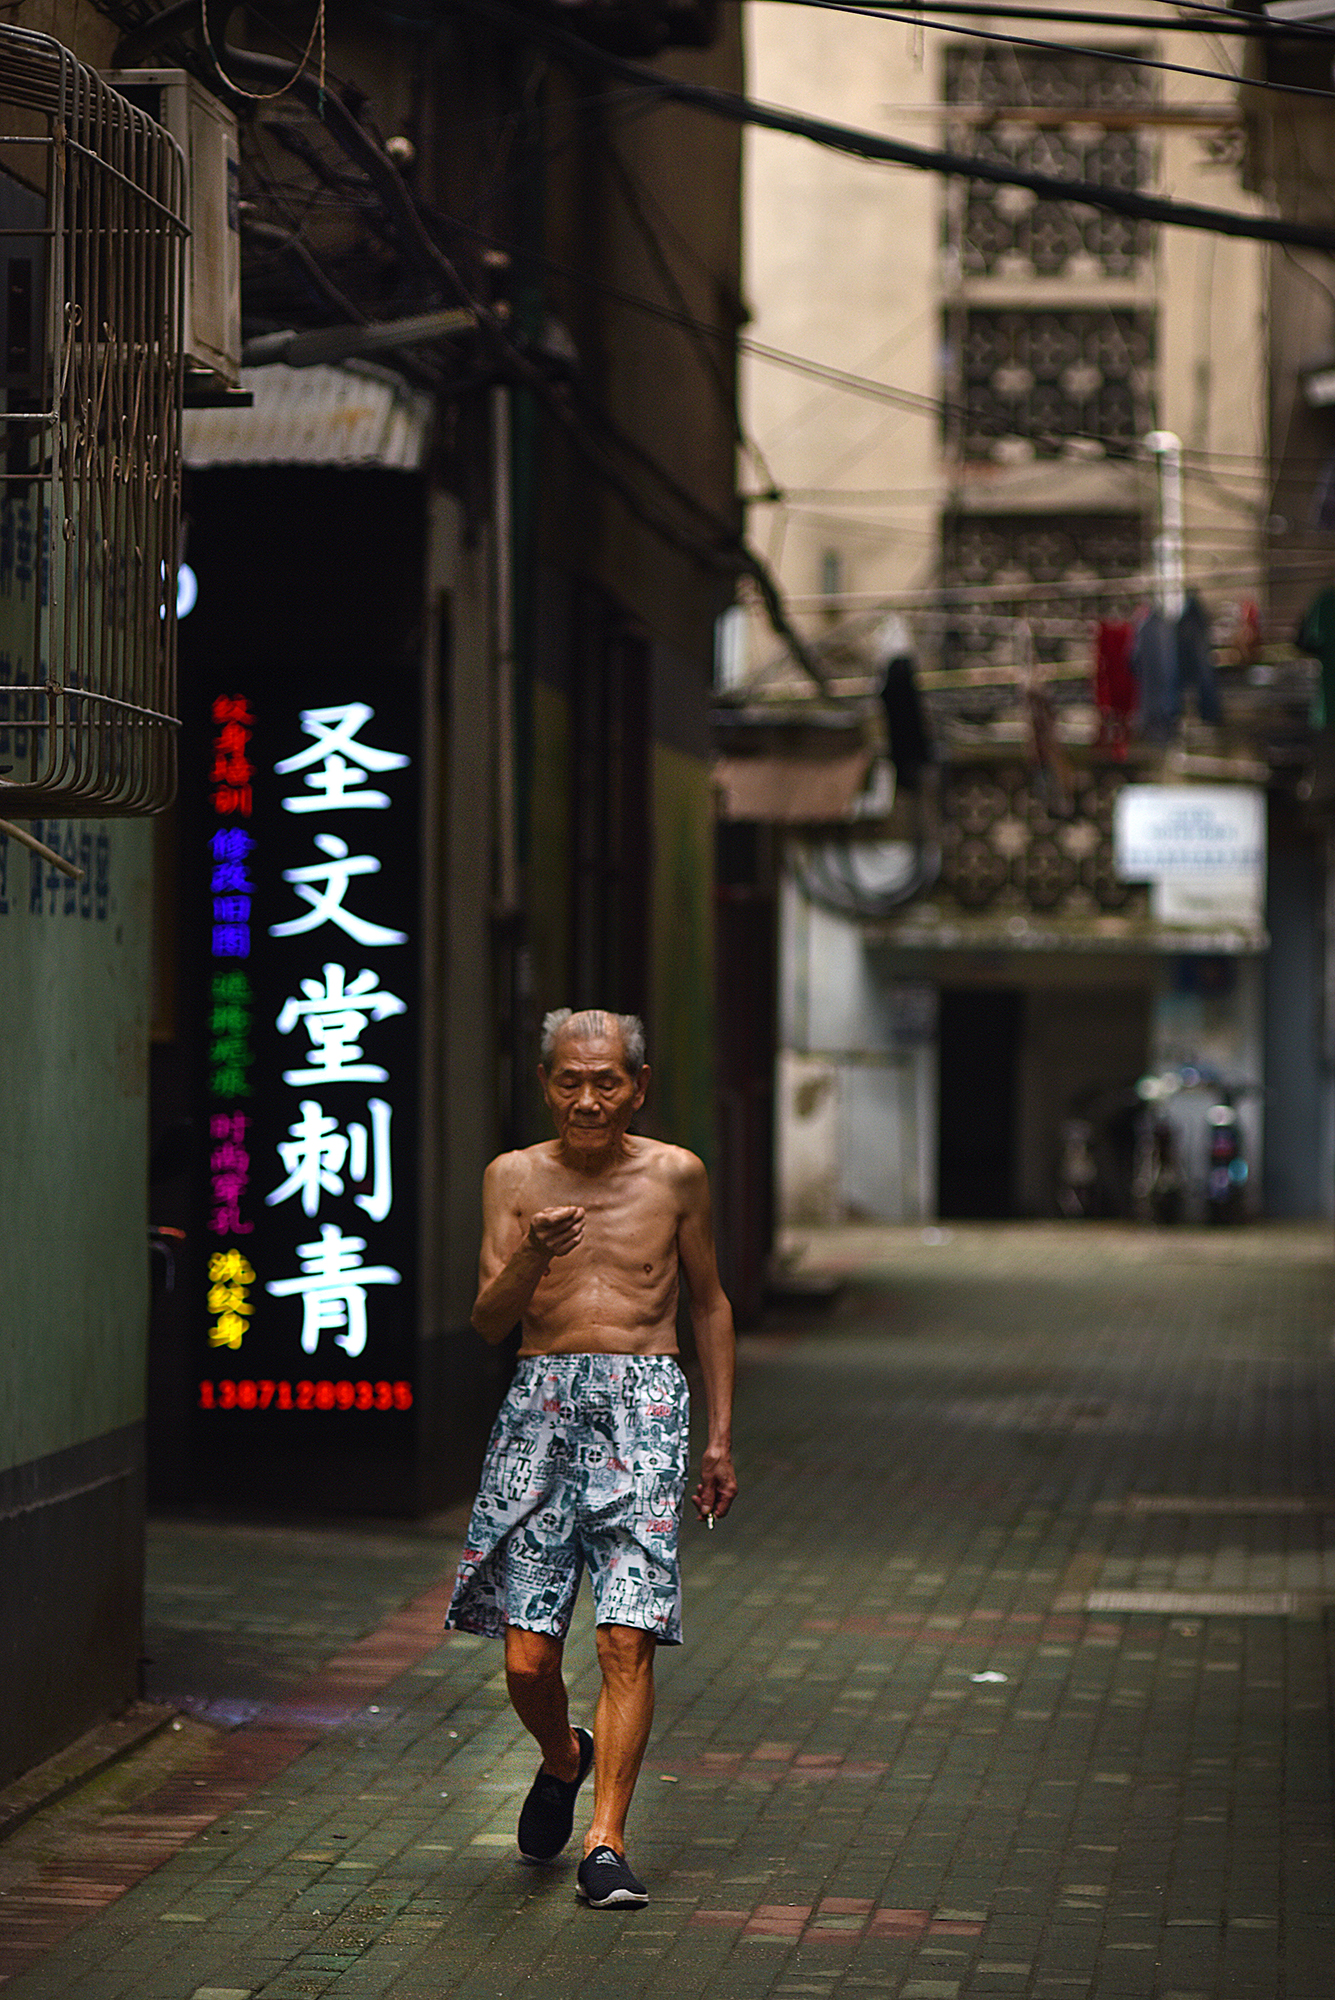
446, 1008, 737, 1910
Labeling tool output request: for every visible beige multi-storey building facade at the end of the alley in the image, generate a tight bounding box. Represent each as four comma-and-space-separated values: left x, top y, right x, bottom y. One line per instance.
735, 6, 1331, 1222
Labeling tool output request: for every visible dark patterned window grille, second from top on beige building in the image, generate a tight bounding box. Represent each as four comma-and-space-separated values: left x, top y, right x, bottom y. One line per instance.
947, 306, 1155, 460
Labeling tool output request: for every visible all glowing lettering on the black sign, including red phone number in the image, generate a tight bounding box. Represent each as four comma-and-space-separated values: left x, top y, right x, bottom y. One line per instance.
200, 694, 416, 1410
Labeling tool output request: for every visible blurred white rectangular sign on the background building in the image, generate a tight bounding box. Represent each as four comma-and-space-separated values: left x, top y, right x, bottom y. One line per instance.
1113, 784, 1265, 882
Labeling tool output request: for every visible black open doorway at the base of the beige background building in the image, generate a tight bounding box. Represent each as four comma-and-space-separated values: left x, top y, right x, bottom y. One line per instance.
937, 986, 1023, 1222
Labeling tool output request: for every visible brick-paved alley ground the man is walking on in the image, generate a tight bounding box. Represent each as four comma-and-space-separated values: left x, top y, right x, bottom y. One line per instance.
0, 1226, 1335, 2000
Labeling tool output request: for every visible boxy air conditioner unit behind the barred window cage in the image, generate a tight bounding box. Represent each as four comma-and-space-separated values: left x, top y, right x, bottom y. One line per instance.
106, 70, 242, 402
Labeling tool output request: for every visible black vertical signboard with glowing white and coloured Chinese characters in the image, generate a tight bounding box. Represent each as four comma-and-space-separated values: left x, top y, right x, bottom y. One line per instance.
182, 468, 422, 1486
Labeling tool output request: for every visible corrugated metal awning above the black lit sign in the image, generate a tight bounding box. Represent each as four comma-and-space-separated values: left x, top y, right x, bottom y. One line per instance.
182, 362, 432, 472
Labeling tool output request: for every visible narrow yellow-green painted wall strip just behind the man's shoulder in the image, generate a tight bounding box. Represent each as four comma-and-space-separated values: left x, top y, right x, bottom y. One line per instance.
650, 744, 713, 1166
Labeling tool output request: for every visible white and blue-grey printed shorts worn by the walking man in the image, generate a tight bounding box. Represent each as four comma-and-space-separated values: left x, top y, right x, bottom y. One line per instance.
446, 1354, 689, 1646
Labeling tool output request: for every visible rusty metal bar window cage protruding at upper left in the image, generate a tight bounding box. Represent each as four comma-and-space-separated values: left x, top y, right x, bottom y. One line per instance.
0, 28, 186, 818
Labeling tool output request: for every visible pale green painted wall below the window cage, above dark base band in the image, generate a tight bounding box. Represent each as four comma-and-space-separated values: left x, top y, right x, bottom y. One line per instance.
0, 820, 152, 1470
